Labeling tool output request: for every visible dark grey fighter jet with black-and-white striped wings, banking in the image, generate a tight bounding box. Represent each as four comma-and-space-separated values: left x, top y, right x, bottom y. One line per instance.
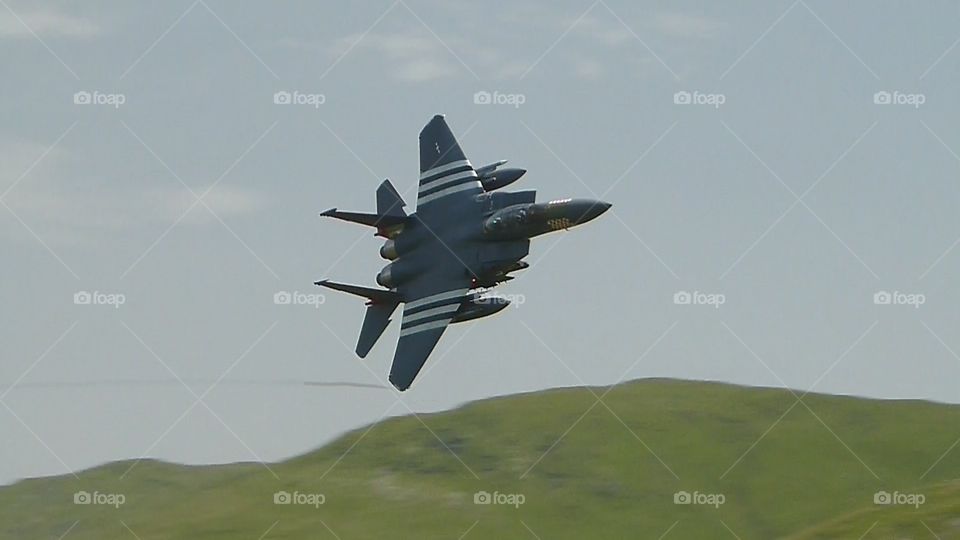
316, 115, 610, 391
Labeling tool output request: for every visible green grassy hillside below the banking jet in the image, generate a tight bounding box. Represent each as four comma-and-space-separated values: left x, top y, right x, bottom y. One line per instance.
0, 380, 960, 540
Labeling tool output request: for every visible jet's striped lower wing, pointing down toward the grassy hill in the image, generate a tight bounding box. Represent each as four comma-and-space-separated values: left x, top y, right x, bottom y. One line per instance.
390, 278, 470, 391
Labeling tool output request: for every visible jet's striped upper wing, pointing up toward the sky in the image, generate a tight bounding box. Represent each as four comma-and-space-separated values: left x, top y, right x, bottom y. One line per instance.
417, 115, 483, 211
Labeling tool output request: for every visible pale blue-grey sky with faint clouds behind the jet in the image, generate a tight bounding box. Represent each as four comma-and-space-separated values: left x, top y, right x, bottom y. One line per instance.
0, 0, 960, 483
